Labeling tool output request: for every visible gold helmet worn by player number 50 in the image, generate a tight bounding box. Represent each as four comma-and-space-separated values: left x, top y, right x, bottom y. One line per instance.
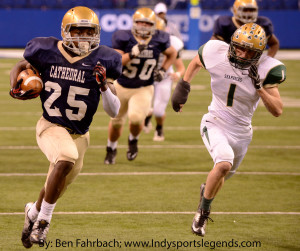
132, 7, 156, 39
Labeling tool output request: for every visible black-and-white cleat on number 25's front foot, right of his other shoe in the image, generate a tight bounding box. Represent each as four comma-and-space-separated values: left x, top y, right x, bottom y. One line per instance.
30, 219, 50, 247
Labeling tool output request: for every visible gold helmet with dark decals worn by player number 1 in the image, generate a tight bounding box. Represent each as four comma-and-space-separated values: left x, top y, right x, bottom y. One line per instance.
228, 23, 267, 69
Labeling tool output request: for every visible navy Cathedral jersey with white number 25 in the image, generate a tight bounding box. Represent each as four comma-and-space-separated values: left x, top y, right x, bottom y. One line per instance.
24, 37, 122, 134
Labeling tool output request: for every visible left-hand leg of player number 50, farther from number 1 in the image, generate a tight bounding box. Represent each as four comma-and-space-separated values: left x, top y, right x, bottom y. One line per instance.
104, 81, 129, 165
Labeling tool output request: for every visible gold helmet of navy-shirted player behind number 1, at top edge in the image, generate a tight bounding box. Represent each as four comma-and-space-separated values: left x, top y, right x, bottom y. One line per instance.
232, 0, 258, 24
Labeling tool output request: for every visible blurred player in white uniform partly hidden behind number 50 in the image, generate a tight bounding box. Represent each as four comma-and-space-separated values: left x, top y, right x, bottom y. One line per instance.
144, 17, 185, 141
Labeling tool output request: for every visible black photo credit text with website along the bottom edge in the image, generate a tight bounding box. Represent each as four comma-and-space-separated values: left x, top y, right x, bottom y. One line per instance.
41, 238, 262, 250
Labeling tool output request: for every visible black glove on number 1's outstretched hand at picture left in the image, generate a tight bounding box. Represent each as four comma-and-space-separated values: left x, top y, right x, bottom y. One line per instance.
171, 79, 191, 112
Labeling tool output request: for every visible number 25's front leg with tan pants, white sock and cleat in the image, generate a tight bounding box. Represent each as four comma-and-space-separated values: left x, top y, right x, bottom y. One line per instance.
30, 118, 78, 245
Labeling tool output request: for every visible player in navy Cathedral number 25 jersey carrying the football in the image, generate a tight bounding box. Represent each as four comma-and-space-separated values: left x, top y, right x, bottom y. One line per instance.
10, 6, 122, 248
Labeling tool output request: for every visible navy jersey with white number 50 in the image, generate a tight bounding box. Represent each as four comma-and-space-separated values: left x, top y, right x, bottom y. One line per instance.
112, 30, 170, 88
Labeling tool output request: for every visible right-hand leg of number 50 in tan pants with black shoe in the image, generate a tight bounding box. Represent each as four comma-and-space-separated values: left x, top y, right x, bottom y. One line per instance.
127, 85, 153, 160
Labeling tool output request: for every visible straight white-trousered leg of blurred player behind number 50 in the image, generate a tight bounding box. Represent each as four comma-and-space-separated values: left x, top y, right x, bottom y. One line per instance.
153, 77, 172, 141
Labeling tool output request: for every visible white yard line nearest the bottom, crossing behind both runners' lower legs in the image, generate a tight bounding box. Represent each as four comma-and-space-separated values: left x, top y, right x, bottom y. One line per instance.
0, 211, 300, 216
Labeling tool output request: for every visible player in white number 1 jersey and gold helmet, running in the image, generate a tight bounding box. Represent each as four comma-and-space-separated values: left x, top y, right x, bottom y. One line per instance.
172, 23, 286, 236
